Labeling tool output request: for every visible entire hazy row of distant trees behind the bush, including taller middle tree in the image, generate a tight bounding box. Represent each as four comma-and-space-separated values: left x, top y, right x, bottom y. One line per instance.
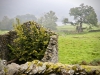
0, 11, 58, 30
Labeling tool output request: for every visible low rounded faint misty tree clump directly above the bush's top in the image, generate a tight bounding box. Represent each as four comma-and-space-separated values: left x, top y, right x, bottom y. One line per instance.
16, 14, 37, 23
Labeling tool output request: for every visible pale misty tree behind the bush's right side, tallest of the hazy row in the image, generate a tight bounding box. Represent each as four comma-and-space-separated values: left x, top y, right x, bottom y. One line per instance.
38, 11, 58, 30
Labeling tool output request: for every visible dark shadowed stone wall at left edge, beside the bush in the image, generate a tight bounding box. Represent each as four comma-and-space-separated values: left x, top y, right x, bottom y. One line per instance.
0, 31, 16, 60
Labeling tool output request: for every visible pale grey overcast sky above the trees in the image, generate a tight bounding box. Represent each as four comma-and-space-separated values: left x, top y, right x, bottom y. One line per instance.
0, 0, 100, 20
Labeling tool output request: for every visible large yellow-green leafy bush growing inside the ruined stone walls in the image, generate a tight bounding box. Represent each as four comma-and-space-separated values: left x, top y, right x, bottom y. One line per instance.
9, 21, 54, 62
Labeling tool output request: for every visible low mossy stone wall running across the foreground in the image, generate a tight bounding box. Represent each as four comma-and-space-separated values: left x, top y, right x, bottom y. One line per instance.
0, 60, 100, 75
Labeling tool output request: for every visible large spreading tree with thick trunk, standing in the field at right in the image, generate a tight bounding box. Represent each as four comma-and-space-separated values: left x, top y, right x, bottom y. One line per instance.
69, 4, 98, 32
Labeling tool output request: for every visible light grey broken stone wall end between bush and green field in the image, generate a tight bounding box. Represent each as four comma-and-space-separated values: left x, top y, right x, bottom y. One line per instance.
42, 35, 58, 63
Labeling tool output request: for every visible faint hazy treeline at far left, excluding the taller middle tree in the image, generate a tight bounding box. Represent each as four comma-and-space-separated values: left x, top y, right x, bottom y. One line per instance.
0, 14, 37, 30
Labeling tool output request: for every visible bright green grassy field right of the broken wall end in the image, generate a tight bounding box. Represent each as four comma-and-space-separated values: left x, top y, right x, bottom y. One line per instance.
58, 32, 100, 64
